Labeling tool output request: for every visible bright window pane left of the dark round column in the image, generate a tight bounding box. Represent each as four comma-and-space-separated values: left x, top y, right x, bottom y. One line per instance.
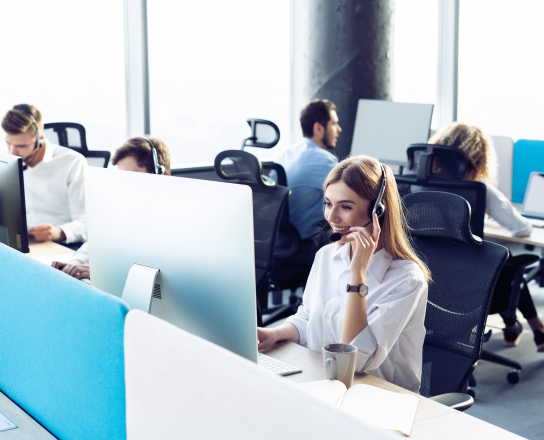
148, 0, 290, 166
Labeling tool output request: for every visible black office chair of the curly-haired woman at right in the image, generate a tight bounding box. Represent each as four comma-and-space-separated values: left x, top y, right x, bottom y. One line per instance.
395, 144, 539, 388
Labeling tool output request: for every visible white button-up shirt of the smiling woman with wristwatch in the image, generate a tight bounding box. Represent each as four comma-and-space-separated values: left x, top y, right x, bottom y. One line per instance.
287, 244, 427, 393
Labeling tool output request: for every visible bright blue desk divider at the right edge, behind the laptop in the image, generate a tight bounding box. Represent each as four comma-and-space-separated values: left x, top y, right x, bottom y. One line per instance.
512, 139, 544, 203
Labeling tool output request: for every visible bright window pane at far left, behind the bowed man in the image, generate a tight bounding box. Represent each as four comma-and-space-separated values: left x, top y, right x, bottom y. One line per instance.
0, 0, 126, 151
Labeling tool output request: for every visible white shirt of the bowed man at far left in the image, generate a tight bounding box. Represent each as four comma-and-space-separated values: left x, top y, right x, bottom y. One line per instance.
23, 140, 87, 243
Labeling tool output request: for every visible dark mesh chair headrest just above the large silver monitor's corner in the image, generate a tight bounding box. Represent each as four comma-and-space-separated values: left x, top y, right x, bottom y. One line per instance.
214, 150, 276, 188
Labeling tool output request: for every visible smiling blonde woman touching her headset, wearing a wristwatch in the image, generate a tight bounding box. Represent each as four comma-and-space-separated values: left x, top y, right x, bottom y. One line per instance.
258, 156, 431, 392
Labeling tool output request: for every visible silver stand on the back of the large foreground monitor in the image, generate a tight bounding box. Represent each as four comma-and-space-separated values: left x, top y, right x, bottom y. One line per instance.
121, 264, 160, 313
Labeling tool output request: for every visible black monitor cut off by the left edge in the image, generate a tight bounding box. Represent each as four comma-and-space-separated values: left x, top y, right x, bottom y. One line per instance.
0, 153, 29, 253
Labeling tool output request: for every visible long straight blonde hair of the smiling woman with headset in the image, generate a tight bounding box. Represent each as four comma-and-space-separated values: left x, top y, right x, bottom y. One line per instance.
323, 155, 431, 282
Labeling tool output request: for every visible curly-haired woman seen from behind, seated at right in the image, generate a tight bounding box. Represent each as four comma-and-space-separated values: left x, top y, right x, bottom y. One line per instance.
429, 122, 544, 352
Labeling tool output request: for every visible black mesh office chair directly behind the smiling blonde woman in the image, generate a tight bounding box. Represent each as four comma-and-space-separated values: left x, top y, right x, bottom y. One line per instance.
403, 191, 508, 409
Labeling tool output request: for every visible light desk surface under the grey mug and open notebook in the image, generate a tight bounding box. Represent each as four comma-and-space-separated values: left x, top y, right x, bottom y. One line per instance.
263, 342, 522, 440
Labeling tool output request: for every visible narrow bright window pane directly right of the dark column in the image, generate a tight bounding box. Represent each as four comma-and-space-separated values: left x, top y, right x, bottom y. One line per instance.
393, 0, 439, 127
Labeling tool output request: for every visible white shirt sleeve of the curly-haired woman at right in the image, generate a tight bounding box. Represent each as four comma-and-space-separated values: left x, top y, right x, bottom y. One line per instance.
483, 181, 533, 237
